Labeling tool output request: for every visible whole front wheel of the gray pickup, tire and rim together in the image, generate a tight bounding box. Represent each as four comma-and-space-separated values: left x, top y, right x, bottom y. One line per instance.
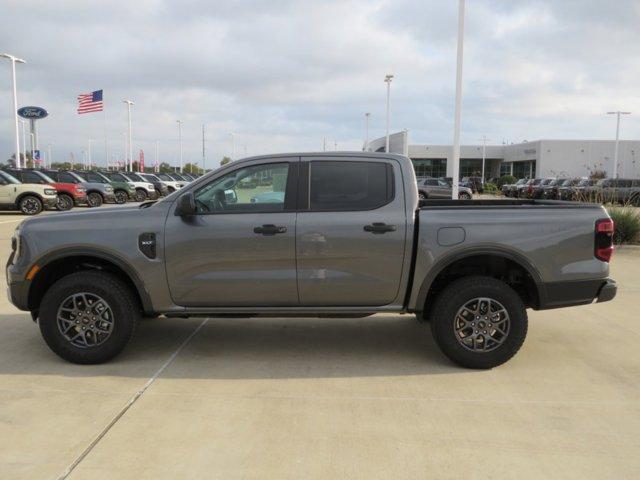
38, 271, 140, 364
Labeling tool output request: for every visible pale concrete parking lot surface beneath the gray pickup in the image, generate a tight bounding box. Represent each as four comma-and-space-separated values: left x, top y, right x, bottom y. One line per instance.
0, 212, 640, 480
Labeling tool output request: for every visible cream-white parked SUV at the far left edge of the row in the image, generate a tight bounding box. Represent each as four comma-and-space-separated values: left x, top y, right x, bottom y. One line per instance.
0, 170, 58, 215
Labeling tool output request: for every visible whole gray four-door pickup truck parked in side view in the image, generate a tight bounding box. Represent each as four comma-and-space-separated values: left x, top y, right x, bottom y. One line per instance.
7, 153, 616, 368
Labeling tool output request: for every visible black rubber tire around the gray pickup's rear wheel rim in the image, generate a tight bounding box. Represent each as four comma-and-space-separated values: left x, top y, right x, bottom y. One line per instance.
430, 276, 528, 369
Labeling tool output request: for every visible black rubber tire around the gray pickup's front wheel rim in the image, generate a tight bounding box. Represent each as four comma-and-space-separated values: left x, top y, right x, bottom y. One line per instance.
38, 271, 141, 364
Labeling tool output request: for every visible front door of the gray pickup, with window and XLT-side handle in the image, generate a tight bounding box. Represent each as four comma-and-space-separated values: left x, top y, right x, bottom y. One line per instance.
165, 157, 299, 306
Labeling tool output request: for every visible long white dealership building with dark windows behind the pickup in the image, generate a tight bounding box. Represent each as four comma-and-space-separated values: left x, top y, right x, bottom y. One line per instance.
365, 131, 640, 178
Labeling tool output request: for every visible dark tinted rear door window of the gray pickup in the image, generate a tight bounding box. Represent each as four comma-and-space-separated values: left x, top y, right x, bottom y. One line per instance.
309, 161, 393, 211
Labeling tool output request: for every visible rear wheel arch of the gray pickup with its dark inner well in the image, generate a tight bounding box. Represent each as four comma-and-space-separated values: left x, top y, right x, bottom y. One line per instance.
415, 247, 546, 313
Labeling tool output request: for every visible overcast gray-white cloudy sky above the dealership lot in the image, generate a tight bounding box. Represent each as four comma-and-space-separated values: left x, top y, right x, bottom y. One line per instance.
0, 0, 640, 167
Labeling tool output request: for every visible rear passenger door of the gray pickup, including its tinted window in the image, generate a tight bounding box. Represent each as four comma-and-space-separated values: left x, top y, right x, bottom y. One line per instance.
296, 157, 406, 306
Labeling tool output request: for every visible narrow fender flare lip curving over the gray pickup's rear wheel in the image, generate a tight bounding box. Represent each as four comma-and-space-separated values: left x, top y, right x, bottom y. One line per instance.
415, 246, 546, 311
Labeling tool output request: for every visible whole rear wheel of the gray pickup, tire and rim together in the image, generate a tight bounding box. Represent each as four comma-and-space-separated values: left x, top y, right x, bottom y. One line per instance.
430, 276, 528, 369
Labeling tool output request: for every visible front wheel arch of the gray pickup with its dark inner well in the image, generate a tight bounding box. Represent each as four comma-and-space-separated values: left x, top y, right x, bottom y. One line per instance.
27, 248, 154, 314
